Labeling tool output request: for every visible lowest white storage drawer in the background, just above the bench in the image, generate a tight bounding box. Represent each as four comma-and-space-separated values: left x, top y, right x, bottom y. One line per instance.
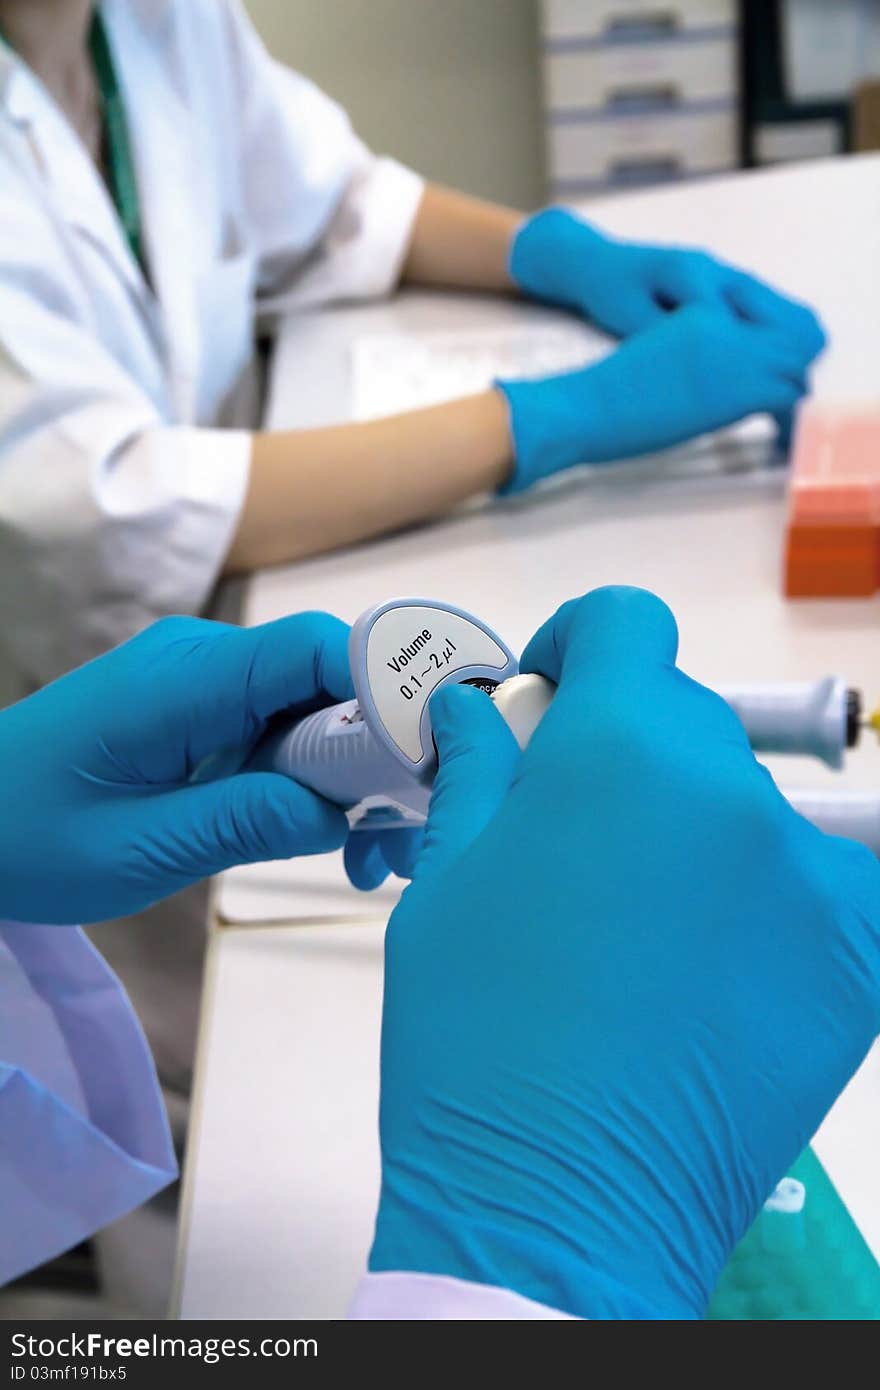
546, 104, 737, 195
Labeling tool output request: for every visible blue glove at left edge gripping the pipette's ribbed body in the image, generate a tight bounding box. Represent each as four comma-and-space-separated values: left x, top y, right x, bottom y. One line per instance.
0, 613, 353, 922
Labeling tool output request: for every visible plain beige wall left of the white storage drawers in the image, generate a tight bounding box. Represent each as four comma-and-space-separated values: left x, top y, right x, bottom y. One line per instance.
246, 0, 542, 207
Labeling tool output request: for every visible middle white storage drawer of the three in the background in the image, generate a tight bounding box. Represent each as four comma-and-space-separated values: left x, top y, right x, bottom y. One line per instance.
544, 36, 737, 113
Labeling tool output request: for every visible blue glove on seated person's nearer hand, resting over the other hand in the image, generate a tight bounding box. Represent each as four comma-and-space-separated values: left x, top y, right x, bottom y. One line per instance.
496, 306, 808, 492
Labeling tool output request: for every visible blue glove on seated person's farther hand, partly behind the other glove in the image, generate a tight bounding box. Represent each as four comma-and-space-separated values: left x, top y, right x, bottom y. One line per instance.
510, 207, 824, 361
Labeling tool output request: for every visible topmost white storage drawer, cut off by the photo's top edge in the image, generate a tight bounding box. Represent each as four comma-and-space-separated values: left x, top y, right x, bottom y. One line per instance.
541, 0, 737, 42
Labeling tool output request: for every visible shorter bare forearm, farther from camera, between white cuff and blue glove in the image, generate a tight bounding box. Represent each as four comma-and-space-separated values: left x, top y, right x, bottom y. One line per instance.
403, 183, 523, 292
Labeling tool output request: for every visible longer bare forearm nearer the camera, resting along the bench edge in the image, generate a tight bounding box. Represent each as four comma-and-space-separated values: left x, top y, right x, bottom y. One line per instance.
224, 391, 512, 574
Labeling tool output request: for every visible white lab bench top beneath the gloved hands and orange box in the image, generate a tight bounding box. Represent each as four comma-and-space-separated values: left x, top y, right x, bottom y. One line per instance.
177, 156, 880, 1318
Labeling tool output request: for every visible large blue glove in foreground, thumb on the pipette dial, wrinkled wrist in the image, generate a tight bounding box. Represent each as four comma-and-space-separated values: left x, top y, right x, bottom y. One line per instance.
370, 588, 880, 1318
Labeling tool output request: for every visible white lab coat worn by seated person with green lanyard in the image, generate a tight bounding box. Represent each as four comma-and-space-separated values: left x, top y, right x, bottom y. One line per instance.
0, 0, 423, 695
